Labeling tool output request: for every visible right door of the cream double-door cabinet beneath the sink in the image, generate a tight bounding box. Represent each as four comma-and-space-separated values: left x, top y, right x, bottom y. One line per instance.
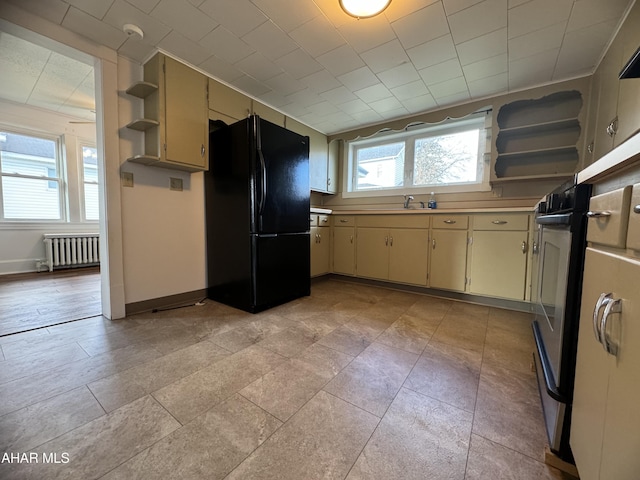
389, 229, 429, 286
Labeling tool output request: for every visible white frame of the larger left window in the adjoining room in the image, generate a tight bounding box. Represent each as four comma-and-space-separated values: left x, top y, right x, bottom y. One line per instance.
0, 128, 68, 223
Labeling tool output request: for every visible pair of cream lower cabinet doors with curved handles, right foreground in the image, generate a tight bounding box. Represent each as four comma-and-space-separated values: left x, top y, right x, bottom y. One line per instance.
571, 248, 640, 480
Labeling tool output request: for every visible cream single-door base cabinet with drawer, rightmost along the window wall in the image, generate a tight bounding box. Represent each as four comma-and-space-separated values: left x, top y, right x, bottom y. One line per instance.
467, 214, 529, 300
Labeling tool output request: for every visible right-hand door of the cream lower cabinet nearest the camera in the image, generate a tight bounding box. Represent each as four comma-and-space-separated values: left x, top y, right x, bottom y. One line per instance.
598, 253, 640, 480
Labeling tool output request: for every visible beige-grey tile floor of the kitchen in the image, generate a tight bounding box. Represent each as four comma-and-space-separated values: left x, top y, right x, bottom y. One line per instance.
0, 279, 569, 480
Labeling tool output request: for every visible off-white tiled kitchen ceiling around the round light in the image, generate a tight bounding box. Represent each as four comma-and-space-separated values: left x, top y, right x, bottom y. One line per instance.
3, 0, 634, 134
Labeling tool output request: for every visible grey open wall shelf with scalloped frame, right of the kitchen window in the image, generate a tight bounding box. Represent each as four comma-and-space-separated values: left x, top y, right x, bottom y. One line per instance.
491, 90, 582, 183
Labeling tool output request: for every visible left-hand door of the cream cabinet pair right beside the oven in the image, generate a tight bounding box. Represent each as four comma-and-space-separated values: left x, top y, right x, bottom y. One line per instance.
570, 248, 616, 480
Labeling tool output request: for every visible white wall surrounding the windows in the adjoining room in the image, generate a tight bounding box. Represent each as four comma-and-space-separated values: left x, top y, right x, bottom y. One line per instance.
0, 101, 99, 275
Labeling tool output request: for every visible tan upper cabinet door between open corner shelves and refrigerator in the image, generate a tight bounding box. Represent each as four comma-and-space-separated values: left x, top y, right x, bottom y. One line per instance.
164, 57, 209, 169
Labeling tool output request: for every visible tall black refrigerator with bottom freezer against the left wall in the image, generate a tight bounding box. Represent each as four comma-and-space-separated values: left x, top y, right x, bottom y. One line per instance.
205, 115, 310, 313
